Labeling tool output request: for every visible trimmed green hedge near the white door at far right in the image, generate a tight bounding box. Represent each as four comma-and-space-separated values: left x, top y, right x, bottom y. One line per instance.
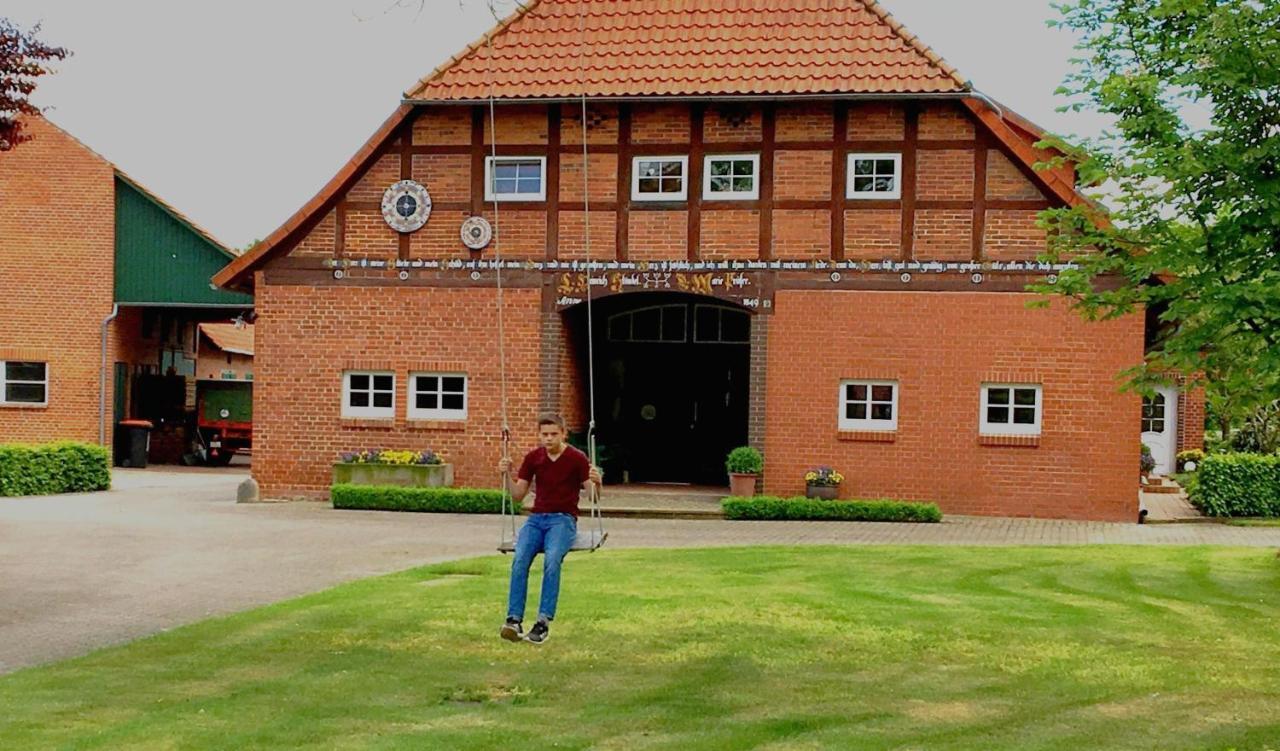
1192, 454, 1280, 517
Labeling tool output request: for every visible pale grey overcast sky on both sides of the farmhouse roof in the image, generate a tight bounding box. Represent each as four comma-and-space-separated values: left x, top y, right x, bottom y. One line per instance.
0, 0, 1098, 247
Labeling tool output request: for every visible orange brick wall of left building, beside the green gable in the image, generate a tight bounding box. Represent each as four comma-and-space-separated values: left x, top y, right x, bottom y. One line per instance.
0, 118, 118, 443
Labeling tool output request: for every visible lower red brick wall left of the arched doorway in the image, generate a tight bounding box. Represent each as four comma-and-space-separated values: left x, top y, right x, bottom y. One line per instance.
253, 284, 539, 498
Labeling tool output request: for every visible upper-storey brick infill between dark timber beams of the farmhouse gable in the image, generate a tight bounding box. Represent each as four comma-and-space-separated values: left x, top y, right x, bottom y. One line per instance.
282, 102, 1070, 267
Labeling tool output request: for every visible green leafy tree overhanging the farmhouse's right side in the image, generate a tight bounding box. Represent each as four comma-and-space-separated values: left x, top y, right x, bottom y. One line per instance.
1037, 0, 1280, 432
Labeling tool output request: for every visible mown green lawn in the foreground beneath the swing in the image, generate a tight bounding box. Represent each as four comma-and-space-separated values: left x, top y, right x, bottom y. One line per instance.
0, 546, 1280, 751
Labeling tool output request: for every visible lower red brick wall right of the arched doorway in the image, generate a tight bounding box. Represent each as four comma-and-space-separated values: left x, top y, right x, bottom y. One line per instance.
764, 292, 1143, 521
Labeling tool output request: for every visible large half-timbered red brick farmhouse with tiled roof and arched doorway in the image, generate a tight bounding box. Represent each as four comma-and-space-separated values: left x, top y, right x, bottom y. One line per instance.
215, 0, 1198, 521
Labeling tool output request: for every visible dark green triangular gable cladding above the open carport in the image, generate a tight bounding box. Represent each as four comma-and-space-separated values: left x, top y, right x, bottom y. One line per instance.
115, 171, 253, 308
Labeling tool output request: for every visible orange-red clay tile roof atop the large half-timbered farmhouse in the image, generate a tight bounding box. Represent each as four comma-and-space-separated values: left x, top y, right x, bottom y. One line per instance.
404, 0, 969, 101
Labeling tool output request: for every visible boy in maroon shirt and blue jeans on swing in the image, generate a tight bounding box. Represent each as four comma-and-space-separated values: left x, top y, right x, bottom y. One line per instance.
498, 413, 600, 644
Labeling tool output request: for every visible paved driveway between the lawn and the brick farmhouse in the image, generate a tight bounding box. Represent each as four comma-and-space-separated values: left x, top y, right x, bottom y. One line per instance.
0, 470, 1280, 673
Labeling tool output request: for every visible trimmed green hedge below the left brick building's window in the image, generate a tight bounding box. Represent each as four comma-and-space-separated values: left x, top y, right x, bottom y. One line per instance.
0, 440, 111, 495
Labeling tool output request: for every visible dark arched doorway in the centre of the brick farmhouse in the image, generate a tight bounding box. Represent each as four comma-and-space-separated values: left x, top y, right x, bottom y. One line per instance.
563, 292, 751, 485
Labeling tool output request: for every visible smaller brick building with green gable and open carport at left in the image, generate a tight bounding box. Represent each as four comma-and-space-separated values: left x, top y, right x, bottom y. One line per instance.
0, 118, 252, 458
